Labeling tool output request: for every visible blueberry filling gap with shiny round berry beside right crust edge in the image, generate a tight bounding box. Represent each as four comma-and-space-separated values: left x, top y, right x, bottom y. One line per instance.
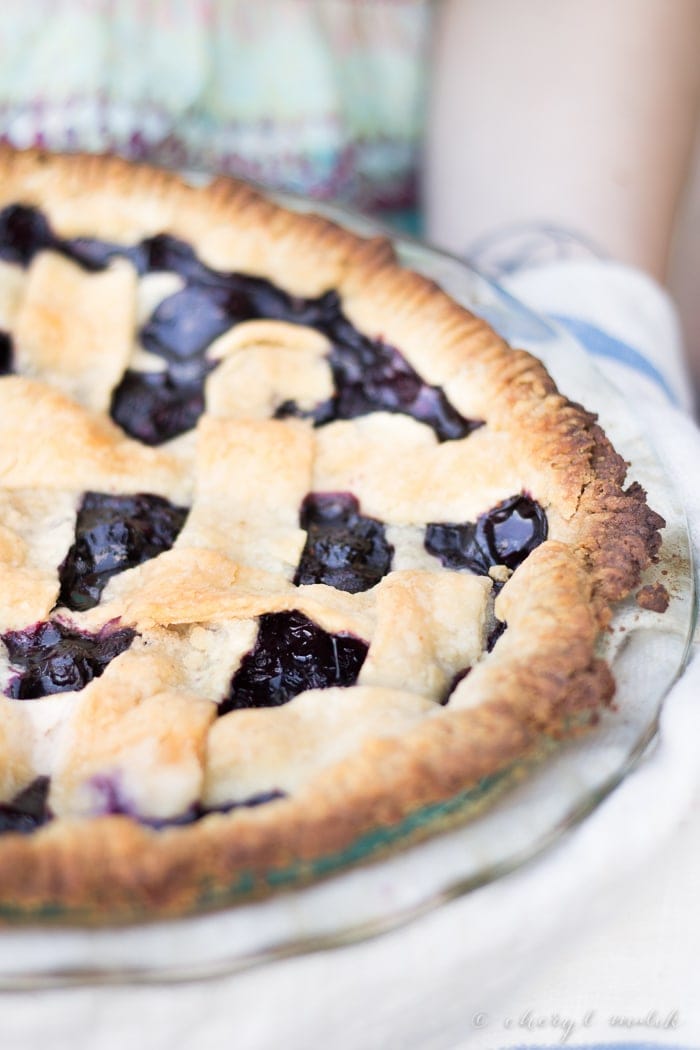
425, 495, 547, 575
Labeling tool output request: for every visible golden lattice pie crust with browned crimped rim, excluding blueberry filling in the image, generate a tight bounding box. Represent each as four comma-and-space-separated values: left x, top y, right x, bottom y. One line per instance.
0, 150, 663, 922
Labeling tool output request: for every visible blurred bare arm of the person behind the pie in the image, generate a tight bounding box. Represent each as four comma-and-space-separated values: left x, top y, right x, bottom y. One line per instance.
426, 0, 700, 280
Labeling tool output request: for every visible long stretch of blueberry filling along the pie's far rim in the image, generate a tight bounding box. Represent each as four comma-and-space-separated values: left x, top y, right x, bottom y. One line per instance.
0, 205, 482, 444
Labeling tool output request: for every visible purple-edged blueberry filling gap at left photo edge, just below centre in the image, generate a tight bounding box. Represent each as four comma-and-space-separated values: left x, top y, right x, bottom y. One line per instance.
0, 620, 136, 700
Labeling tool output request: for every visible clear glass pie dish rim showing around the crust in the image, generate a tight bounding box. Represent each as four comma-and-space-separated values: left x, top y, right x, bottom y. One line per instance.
0, 196, 695, 990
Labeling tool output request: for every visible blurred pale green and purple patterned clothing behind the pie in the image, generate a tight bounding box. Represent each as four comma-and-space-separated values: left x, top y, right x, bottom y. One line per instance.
0, 0, 430, 223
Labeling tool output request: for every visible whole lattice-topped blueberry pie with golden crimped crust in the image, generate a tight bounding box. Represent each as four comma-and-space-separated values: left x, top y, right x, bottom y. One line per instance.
0, 150, 663, 921
